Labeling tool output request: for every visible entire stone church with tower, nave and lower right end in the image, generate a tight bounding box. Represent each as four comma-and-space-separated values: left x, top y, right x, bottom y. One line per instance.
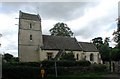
18, 11, 102, 64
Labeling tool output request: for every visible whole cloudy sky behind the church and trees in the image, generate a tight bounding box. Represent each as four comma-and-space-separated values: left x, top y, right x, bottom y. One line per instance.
0, 0, 119, 57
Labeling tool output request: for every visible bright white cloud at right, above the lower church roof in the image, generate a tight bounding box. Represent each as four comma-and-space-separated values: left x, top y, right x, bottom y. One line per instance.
68, 2, 117, 39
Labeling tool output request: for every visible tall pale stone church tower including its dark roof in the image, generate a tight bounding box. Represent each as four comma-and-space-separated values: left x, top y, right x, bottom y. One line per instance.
18, 11, 43, 62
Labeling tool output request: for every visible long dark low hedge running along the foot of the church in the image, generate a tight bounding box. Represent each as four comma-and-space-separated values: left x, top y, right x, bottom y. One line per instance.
3, 61, 91, 68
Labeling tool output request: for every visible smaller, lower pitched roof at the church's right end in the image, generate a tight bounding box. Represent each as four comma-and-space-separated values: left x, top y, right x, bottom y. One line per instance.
79, 42, 98, 52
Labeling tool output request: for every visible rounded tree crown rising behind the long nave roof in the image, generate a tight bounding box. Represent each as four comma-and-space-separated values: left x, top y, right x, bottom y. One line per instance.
49, 22, 73, 37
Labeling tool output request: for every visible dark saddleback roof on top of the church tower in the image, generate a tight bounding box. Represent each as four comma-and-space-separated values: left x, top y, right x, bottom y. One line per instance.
19, 11, 41, 21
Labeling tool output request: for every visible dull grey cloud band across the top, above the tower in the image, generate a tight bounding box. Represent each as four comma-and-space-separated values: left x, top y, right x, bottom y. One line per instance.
2, 2, 97, 21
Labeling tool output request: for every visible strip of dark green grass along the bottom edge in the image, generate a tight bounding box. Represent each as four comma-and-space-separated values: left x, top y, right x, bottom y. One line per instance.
45, 72, 115, 79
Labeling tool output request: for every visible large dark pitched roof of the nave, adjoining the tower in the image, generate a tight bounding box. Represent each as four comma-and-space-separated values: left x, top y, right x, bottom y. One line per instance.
42, 35, 82, 51
